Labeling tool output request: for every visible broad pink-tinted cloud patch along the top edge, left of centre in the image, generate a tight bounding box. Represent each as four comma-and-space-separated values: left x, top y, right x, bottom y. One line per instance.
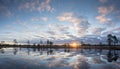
18, 0, 54, 12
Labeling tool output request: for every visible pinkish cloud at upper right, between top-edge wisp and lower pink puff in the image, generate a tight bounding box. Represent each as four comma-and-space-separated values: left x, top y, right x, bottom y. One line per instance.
98, 6, 114, 15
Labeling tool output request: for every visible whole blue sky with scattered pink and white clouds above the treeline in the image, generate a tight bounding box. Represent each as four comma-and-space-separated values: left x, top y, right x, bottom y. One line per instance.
0, 0, 120, 44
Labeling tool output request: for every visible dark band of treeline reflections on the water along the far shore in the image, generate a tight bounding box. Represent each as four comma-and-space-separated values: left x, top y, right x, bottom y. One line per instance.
0, 48, 119, 57
